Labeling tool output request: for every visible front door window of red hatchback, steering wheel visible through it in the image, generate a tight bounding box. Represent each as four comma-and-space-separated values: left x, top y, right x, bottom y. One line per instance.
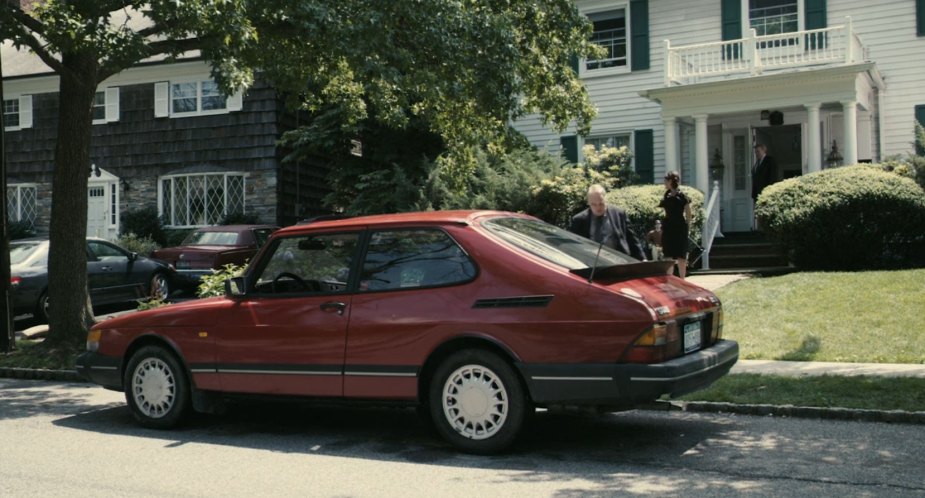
254, 233, 359, 294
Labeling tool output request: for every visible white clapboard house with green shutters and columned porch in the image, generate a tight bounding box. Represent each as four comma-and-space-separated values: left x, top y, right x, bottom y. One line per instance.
516, 0, 925, 232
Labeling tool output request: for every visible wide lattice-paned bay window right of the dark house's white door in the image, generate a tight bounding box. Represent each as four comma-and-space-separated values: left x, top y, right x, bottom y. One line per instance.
160, 173, 245, 227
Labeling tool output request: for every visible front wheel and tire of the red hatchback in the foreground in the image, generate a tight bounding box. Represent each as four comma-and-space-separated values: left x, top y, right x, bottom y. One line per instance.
123, 346, 190, 429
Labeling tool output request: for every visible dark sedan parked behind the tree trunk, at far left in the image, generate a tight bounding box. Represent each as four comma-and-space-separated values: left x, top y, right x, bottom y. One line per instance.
10, 238, 174, 320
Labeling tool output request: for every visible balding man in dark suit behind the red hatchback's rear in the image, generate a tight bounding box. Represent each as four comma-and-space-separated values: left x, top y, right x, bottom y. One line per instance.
569, 184, 646, 261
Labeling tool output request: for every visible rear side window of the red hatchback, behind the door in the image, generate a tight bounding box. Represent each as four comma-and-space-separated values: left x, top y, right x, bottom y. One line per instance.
360, 229, 476, 292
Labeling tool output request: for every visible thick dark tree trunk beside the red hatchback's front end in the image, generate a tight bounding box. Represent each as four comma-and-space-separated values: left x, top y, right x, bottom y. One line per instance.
46, 53, 99, 347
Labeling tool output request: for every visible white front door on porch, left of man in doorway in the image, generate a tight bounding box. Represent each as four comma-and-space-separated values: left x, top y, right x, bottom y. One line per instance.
722, 129, 754, 232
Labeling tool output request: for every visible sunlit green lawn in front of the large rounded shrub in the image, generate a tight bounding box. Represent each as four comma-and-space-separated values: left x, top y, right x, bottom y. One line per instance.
716, 269, 925, 363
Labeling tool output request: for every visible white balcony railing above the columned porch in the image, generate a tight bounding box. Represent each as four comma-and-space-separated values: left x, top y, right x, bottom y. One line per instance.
665, 17, 867, 86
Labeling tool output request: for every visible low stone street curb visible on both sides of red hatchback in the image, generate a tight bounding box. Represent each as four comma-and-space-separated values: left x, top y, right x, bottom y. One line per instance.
7, 368, 925, 425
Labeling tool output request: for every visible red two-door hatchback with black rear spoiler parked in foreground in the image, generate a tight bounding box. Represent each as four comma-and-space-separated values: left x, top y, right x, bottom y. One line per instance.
78, 211, 739, 453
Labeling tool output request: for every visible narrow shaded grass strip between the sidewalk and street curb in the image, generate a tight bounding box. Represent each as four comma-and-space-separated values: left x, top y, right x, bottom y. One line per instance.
680, 374, 925, 412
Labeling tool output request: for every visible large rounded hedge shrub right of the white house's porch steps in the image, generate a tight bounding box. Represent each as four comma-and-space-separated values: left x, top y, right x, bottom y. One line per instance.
756, 166, 925, 270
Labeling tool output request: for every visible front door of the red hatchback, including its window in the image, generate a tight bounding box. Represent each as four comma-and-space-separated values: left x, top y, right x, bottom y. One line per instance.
215, 232, 361, 396
